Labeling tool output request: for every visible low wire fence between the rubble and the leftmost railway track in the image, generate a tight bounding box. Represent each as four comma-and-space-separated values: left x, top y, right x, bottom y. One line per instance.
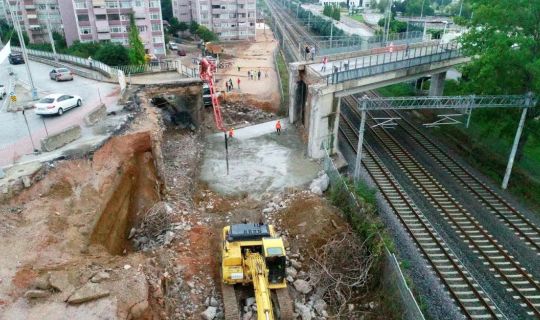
324, 149, 425, 320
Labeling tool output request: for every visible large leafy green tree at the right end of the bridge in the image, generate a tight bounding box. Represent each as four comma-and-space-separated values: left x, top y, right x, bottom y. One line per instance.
460, 0, 540, 160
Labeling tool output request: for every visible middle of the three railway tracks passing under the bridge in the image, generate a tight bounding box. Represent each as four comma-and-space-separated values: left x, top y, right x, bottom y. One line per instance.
346, 97, 540, 318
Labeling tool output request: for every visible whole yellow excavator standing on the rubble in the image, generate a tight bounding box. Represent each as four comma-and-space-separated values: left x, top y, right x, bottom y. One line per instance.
221, 223, 293, 320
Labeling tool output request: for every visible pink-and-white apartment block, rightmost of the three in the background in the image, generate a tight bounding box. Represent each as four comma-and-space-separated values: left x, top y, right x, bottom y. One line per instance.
173, 0, 257, 40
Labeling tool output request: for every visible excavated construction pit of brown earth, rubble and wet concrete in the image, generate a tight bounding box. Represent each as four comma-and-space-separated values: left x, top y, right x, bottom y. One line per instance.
0, 87, 387, 320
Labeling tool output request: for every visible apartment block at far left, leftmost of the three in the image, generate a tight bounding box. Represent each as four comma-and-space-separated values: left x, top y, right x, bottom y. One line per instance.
4, 0, 63, 43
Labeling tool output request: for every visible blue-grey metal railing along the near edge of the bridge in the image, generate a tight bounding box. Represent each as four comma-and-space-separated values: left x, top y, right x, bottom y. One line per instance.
326, 43, 463, 84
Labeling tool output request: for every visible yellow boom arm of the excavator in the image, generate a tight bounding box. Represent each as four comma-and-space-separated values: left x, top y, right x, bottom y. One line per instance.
244, 252, 276, 320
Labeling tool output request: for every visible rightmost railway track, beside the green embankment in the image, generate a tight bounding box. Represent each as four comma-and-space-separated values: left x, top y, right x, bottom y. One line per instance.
368, 92, 540, 255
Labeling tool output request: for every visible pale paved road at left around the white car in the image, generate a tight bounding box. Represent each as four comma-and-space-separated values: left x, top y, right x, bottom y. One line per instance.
0, 61, 119, 166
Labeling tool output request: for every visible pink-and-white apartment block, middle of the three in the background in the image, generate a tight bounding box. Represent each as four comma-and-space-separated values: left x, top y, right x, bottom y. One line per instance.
58, 0, 165, 56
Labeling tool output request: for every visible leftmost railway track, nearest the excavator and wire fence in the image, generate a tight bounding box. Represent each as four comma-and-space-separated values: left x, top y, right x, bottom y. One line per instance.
339, 108, 506, 319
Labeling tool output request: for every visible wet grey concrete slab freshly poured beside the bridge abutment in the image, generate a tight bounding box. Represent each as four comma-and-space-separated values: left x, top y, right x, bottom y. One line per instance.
201, 119, 322, 199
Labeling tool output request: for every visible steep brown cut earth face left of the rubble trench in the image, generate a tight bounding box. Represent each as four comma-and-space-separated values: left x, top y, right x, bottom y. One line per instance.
90, 133, 161, 255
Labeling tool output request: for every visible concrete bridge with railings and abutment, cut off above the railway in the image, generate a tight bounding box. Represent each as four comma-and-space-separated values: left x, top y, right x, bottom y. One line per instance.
289, 41, 470, 158
